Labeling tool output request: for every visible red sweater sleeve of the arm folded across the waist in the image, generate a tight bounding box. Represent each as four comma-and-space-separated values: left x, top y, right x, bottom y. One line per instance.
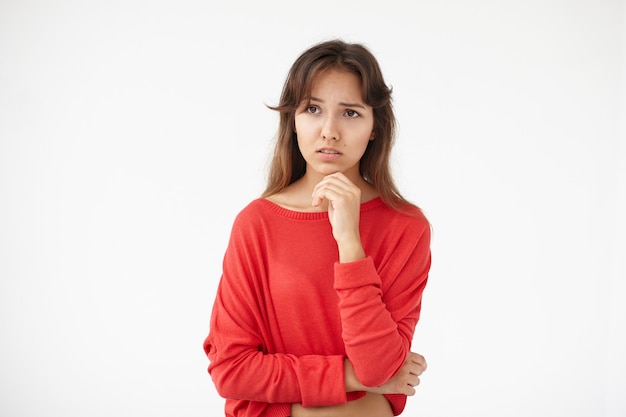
204, 210, 347, 408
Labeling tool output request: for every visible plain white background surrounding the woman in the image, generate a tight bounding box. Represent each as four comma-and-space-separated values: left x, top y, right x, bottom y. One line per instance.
0, 0, 626, 417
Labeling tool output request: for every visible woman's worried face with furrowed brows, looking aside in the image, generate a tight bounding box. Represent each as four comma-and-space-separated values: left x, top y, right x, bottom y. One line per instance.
295, 70, 374, 181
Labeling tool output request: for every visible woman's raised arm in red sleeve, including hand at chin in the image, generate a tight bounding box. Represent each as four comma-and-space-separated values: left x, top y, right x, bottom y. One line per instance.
313, 174, 431, 387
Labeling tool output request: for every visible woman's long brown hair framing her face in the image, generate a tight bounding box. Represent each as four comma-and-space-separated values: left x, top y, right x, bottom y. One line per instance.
262, 40, 412, 211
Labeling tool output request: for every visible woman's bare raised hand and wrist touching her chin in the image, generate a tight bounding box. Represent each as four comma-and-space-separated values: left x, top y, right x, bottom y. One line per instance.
311, 172, 365, 262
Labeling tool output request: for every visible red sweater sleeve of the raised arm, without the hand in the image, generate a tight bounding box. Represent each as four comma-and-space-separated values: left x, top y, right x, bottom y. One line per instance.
334, 219, 431, 387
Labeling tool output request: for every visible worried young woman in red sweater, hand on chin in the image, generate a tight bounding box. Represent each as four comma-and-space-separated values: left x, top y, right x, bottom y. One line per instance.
204, 40, 430, 417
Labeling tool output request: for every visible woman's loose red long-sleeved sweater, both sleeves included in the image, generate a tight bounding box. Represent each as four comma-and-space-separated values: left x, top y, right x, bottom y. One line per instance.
204, 198, 430, 417
